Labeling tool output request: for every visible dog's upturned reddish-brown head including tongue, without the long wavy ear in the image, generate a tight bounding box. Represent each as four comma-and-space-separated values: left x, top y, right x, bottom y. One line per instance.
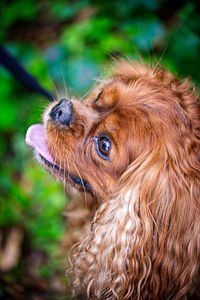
28, 62, 197, 199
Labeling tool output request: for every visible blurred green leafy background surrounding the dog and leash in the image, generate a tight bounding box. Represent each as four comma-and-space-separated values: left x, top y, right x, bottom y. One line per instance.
0, 0, 200, 300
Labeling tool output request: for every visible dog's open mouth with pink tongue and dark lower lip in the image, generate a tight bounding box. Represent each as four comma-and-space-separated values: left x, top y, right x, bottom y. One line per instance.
26, 124, 92, 191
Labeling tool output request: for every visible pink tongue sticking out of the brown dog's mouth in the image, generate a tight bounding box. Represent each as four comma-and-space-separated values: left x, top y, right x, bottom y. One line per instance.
25, 124, 55, 164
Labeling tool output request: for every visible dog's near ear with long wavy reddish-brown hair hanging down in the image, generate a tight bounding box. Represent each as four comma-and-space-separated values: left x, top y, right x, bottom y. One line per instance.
75, 139, 200, 299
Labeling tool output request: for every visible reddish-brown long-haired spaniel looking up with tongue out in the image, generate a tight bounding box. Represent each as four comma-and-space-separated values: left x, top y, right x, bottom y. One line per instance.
26, 60, 200, 300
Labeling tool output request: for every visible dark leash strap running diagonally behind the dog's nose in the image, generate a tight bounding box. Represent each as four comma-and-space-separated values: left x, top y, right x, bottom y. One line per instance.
0, 46, 55, 101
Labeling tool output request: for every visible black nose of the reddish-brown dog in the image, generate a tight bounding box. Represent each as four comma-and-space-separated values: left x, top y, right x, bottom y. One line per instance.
50, 99, 73, 126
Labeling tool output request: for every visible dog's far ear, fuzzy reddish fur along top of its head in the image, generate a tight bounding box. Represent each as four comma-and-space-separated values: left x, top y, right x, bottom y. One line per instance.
113, 59, 200, 138
